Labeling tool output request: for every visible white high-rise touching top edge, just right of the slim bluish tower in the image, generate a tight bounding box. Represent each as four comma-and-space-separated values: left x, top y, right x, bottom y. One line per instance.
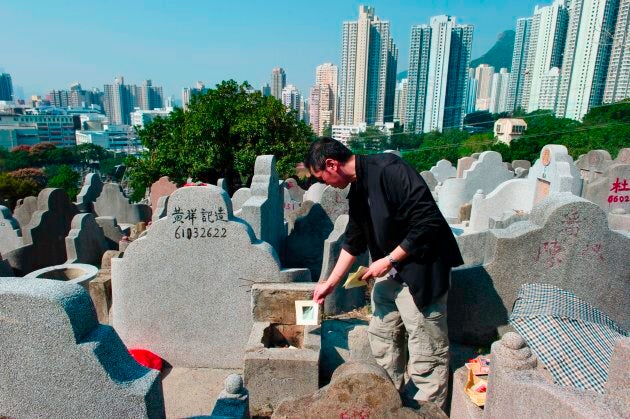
523, 0, 569, 112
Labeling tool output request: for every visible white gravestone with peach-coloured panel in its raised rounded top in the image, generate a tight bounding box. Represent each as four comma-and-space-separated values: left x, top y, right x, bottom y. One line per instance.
469, 144, 582, 231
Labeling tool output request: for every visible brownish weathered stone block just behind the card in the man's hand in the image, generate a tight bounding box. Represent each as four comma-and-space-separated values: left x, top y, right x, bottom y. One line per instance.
252, 283, 315, 324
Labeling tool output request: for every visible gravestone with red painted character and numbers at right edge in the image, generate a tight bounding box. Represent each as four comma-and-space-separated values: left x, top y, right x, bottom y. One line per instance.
583, 163, 630, 214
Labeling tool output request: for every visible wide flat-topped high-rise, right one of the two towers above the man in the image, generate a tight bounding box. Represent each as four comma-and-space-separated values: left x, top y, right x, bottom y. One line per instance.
405, 15, 473, 132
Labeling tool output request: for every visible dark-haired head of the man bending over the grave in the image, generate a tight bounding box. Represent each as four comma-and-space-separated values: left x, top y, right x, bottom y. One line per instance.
304, 137, 355, 188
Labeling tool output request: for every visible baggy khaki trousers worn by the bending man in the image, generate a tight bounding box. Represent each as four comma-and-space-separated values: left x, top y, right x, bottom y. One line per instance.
369, 277, 449, 408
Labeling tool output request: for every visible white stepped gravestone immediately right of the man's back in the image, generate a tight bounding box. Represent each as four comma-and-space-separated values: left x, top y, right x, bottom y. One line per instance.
438, 151, 514, 223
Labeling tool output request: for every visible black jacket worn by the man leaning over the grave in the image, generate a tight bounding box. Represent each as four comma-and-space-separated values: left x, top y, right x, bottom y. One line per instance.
342, 153, 464, 309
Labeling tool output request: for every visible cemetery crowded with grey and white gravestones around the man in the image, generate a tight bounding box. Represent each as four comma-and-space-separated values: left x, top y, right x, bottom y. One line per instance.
0, 144, 630, 418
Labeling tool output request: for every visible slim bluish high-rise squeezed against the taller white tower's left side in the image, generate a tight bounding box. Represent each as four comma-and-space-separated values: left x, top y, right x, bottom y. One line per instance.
507, 17, 532, 112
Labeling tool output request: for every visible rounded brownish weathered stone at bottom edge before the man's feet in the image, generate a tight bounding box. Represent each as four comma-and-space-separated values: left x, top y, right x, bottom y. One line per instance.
272, 362, 447, 419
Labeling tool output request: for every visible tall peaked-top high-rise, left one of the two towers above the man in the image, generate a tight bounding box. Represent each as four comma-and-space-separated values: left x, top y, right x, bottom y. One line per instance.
339, 6, 398, 125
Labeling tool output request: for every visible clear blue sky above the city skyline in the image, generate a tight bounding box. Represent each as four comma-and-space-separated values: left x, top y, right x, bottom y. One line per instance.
0, 0, 549, 99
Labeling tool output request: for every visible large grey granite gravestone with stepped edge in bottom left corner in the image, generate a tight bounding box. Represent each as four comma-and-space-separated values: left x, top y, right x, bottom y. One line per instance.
0, 278, 164, 418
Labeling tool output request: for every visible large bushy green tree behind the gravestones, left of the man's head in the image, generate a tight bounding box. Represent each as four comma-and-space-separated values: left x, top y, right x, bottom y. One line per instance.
127, 80, 313, 202
